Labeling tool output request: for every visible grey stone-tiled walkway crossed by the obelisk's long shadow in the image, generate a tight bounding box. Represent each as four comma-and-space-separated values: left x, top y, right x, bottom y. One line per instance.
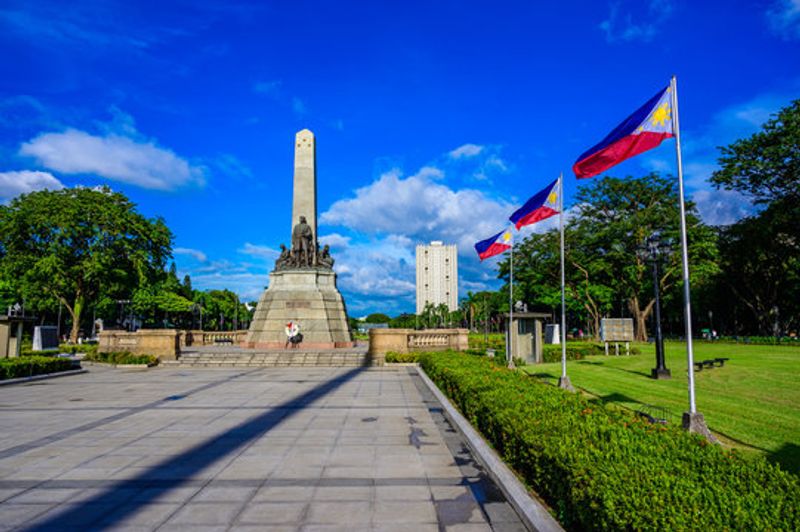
0, 366, 523, 532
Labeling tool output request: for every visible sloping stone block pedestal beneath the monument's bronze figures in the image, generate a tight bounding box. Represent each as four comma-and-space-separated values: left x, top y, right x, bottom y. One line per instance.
242, 268, 355, 349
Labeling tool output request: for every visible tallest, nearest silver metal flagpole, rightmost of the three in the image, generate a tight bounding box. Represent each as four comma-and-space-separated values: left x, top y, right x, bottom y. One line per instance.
670, 76, 713, 439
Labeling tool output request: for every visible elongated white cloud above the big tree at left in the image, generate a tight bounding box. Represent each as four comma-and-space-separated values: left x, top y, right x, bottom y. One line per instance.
19, 122, 205, 190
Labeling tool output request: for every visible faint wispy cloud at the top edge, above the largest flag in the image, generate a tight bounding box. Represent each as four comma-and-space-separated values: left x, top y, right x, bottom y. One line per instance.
599, 0, 674, 43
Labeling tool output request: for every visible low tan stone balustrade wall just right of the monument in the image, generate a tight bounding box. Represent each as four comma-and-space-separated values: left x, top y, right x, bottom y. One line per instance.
369, 329, 469, 365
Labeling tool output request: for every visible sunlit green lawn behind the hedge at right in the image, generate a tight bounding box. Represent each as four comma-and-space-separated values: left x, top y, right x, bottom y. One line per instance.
523, 342, 800, 473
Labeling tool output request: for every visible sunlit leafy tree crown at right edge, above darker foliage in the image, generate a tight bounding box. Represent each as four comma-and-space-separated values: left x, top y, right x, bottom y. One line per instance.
710, 100, 800, 205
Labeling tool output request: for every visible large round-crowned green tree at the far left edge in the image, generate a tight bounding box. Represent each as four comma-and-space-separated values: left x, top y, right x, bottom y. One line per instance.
0, 187, 172, 341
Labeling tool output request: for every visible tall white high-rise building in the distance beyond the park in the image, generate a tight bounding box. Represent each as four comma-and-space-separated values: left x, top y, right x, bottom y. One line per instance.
417, 240, 458, 314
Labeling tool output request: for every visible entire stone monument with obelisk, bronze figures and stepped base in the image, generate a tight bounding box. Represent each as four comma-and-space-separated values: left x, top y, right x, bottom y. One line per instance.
243, 129, 354, 349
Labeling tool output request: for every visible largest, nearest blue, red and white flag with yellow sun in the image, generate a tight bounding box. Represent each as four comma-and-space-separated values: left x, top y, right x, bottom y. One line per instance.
572, 87, 674, 179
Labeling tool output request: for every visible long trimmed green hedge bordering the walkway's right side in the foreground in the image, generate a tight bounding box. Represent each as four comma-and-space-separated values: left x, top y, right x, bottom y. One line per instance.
419, 352, 800, 530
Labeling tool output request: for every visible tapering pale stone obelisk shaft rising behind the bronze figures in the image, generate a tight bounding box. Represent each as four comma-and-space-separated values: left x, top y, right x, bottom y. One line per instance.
291, 129, 317, 249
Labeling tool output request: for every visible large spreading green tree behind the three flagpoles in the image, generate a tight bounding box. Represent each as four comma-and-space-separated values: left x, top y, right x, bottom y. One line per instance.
500, 174, 716, 340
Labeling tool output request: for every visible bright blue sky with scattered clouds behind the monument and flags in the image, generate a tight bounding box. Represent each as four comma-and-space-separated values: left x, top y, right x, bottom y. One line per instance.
0, 0, 800, 316
